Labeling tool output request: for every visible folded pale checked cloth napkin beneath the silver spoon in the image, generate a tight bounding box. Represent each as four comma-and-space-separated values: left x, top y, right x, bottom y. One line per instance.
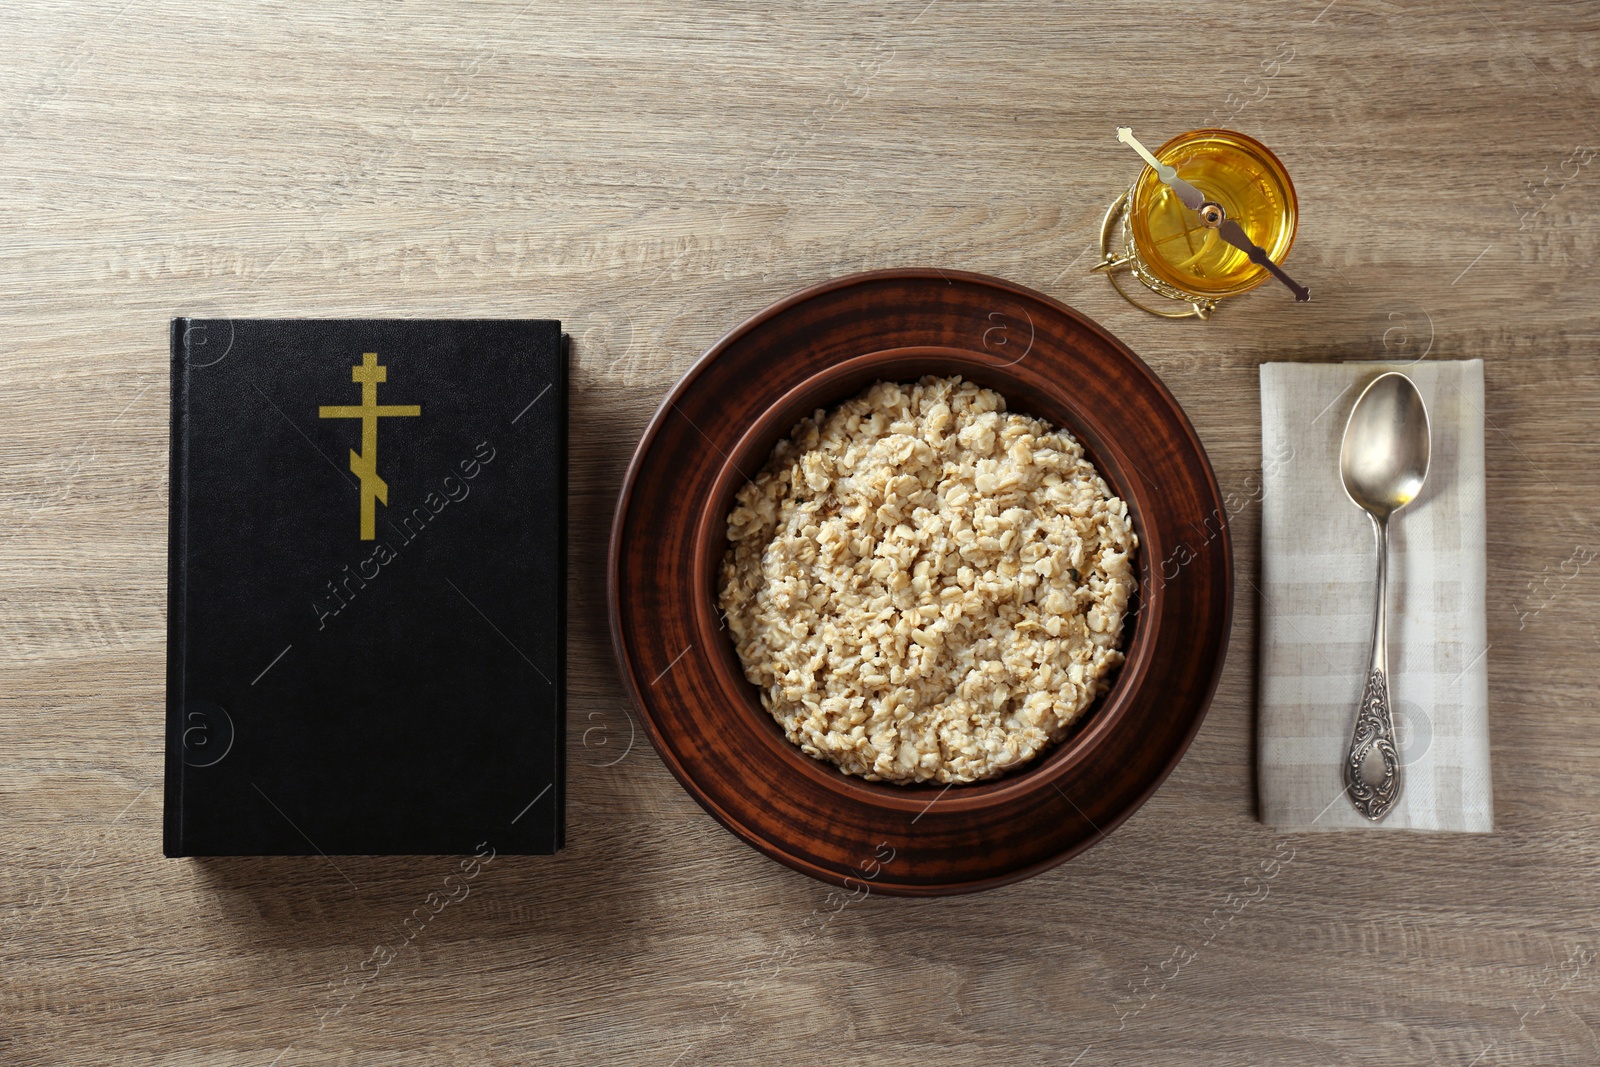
1256, 360, 1494, 833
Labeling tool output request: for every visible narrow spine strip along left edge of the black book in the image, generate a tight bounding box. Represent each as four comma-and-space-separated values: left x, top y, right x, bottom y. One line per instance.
162, 318, 189, 856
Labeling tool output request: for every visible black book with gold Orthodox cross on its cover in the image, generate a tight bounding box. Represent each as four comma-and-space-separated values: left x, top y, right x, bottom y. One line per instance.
165, 318, 566, 856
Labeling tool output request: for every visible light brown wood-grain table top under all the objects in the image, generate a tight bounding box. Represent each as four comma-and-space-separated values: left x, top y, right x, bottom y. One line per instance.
0, 0, 1600, 1067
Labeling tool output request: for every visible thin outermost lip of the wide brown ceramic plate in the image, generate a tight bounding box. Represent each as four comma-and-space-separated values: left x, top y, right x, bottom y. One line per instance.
606, 267, 1235, 896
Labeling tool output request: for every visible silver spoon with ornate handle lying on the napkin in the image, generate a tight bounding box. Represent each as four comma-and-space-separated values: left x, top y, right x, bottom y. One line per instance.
1339, 371, 1430, 822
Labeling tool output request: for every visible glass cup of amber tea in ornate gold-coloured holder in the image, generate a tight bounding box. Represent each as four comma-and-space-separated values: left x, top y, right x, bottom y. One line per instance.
1094, 130, 1298, 318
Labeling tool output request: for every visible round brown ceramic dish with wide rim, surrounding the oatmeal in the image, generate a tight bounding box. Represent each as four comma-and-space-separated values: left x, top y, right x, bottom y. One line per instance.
608, 270, 1234, 896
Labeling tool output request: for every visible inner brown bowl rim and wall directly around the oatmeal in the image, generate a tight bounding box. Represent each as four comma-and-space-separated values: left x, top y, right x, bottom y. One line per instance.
691, 346, 1165, 813
